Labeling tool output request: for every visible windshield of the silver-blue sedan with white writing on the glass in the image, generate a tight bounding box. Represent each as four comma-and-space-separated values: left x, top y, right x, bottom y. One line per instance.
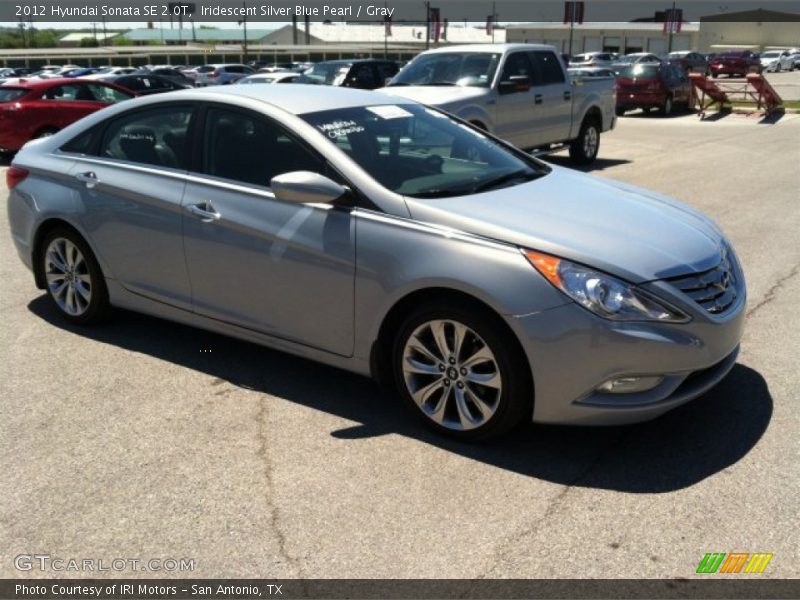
301, 104, 550, 198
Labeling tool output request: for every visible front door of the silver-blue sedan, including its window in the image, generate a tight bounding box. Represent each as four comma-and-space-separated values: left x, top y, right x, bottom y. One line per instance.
183, 105, 355, 356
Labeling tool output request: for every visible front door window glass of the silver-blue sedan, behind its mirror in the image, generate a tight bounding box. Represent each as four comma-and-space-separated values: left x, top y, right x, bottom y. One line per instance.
203, 108, 325, 187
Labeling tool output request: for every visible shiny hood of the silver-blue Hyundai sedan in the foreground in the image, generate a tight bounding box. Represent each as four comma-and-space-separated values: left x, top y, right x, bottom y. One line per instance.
406, 167, 723, 283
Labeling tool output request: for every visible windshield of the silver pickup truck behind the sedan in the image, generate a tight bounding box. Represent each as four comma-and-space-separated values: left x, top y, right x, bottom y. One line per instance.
389, 52, 500, 87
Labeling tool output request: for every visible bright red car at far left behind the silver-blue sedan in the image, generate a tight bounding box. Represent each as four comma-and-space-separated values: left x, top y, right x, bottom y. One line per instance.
0, 78, 136, 152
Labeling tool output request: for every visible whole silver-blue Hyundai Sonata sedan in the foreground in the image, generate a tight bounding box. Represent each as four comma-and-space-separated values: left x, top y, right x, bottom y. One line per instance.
7, 85, 745, 439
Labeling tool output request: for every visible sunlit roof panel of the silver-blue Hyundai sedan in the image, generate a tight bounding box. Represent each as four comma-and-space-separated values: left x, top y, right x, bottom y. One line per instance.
160, 84, 416, 115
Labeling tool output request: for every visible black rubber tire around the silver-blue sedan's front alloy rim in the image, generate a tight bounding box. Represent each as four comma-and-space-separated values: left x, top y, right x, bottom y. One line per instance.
391, 302, 533, 441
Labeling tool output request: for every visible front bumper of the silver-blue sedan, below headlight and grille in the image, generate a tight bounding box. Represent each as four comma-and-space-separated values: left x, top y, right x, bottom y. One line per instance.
509, 301, 745, 425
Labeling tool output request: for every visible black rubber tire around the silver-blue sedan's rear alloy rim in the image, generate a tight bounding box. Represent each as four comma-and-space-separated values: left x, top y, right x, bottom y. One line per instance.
38, 227, 111, 325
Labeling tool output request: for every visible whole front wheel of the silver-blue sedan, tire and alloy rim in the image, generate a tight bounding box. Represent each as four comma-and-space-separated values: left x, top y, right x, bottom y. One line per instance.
392, 305, 532, 440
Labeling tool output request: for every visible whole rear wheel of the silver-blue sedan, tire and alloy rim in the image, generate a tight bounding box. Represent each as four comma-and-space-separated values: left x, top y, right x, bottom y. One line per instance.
39, 228, 110, 325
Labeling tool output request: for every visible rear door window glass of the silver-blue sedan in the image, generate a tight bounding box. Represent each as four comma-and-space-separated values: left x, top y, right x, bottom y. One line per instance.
100, 106, 192, 169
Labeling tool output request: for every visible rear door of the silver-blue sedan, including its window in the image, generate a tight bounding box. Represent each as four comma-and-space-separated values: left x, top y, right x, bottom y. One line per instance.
65, 103, 193, 310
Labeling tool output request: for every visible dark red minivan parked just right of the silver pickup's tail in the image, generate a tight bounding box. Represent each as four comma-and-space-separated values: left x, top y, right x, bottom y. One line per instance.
617, 62, 692, 116
